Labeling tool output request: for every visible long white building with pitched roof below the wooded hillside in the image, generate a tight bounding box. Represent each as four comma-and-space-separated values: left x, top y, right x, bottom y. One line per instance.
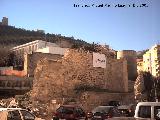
11, 40, 66, 69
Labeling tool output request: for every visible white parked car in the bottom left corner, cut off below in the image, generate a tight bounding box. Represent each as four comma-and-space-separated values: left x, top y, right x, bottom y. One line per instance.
0, 108, 42, 120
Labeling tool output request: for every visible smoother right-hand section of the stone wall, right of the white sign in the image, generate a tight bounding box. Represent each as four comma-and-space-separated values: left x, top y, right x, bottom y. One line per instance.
108, 59, 128, 92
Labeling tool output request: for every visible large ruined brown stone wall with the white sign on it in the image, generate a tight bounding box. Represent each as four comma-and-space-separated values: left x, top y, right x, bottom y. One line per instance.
31, 50, 128, 97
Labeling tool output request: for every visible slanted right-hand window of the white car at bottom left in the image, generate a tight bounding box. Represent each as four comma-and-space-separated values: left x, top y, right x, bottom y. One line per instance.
21, 110, 35, 120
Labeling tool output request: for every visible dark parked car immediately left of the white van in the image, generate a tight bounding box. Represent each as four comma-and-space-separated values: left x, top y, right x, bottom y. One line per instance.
118, 104, 135, 117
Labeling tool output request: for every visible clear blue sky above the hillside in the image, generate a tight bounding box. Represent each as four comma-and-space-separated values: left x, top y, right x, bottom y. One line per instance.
0, 0, 160, 51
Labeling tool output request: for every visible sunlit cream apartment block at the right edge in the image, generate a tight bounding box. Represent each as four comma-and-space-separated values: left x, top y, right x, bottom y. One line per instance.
143, 45, 160, 77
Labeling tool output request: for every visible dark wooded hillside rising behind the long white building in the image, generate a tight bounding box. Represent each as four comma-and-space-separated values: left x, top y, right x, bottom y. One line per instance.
0, 25, 88, 47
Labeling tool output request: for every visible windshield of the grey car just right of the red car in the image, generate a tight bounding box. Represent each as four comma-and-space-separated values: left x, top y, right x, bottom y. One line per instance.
92, 106, 112, 113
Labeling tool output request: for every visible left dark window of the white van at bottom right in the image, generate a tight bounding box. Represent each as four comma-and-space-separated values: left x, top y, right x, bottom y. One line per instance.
138, 106, 151, 118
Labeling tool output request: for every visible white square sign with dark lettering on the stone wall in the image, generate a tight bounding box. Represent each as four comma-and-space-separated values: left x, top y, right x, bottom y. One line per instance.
93, 53, 106, 68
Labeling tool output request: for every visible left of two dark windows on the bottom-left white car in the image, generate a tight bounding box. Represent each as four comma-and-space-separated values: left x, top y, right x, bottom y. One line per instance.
7, 110, 22, 120
